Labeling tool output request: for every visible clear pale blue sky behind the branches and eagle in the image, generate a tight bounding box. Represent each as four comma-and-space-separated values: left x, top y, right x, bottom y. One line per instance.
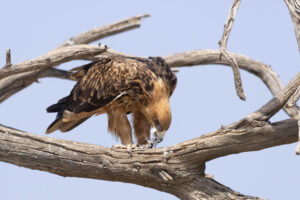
0, 0, 300, 200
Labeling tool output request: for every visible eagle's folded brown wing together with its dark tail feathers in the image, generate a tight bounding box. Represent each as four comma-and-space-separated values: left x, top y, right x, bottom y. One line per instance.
46, 57, 156, 133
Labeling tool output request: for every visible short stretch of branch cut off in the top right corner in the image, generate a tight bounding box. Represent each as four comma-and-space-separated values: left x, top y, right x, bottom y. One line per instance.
284, 0, 300, 51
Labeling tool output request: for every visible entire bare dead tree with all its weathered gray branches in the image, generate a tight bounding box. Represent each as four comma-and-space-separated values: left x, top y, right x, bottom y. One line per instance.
0, 0, 300, 200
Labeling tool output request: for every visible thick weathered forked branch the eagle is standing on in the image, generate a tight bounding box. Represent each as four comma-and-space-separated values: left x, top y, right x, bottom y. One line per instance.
0, 119, 298, 199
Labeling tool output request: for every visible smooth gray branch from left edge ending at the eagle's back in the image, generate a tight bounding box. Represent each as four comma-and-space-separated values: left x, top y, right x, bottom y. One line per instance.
0, 45, 106, 80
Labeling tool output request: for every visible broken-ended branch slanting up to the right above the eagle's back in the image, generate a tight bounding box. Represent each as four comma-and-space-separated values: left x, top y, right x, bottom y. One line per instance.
58, 14, 150, 48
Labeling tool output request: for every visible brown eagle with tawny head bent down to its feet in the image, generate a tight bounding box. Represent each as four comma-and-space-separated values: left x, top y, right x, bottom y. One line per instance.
46, 56, 177, 151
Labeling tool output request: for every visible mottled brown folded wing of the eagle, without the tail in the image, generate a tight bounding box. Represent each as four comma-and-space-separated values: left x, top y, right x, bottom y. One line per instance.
68, 57, 155, 113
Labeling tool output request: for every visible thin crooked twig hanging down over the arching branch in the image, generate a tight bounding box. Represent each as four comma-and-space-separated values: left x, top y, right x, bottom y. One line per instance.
219, 0, 246, 100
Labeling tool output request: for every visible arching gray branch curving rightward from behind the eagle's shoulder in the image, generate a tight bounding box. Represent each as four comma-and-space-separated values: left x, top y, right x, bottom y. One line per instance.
164, 50, 298, 119
